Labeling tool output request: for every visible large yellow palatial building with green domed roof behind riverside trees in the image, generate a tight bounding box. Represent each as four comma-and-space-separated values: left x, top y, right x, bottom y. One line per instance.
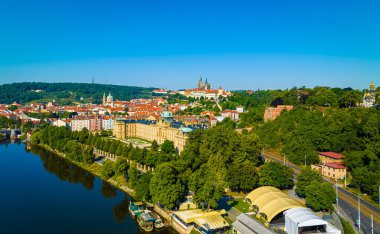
113, 111, 191, 153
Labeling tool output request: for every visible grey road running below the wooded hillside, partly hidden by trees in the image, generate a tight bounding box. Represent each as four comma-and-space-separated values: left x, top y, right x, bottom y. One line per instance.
262, 151, 380, 234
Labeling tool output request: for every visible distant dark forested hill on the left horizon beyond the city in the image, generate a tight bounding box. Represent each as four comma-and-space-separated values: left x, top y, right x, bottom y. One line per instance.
0, 82, 153, 104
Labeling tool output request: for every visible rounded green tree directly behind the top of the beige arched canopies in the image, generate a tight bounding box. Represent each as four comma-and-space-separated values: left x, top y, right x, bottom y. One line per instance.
259, 162, 294, 189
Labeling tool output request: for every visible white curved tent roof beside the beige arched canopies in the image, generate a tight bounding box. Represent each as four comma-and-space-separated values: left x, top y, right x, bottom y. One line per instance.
284, 207, 327, 227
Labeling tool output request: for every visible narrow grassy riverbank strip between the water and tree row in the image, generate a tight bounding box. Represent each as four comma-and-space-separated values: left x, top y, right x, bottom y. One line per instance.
38, 144, 135, 197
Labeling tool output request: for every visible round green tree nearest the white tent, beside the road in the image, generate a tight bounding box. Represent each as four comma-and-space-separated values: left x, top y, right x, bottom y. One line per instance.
305, 180, 336, 211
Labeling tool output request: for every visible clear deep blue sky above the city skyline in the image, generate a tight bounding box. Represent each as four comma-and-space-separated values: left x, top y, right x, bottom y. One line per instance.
0, 0, 380, 89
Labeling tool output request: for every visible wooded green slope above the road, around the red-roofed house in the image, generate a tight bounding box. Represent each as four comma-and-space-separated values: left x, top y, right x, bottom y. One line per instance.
256, 108, 380, 201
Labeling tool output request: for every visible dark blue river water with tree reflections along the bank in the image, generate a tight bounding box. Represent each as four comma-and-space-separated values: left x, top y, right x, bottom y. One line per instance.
0, 143, 174, 234
